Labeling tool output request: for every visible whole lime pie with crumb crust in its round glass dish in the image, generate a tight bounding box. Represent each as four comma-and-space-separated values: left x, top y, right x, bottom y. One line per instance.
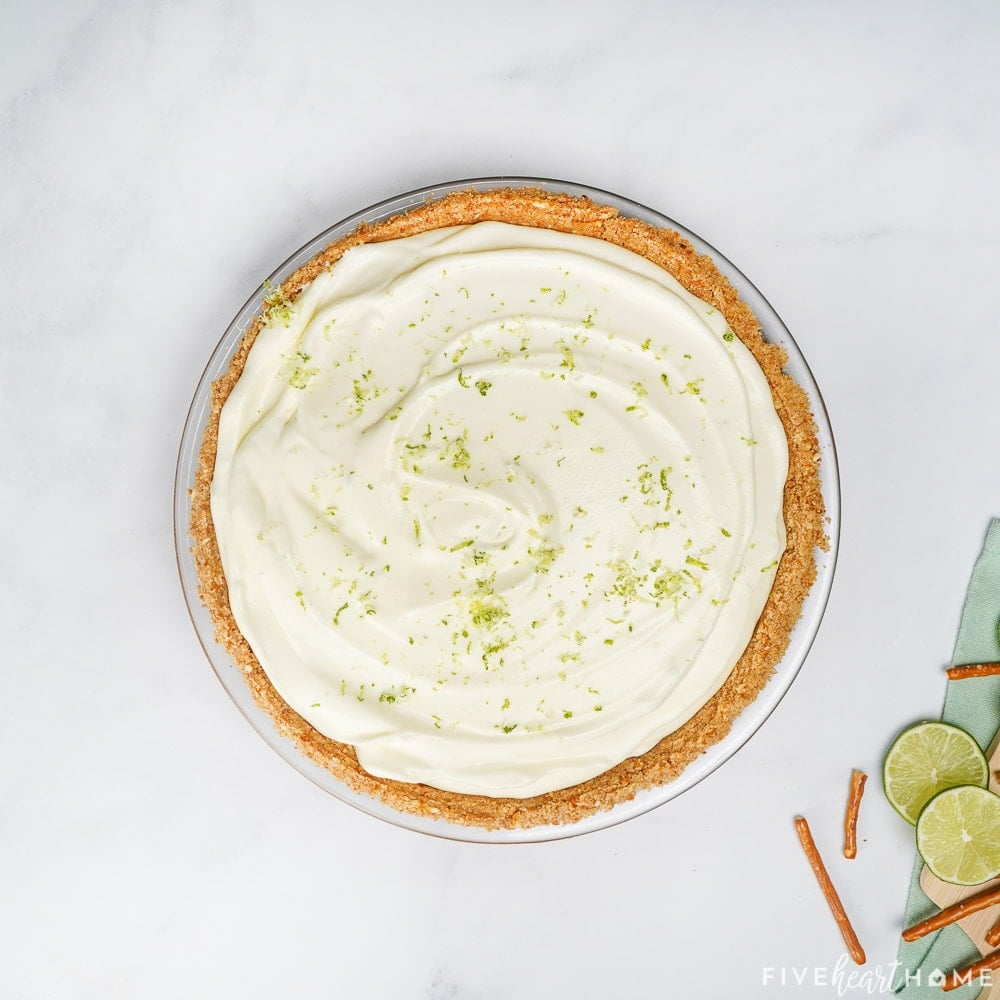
178, 180, 836, 839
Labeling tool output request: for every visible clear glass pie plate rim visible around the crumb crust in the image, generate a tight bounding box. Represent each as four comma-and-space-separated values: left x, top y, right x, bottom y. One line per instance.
174, 177, 840, 843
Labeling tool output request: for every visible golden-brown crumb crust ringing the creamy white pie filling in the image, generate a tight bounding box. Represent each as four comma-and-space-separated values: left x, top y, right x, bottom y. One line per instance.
190, 188, 827, 829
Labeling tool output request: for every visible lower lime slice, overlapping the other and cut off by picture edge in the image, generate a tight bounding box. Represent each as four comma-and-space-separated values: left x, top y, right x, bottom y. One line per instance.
917, 785, 1000, 885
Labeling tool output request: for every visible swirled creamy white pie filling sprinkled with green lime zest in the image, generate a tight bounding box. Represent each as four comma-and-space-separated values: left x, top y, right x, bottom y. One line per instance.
212, 222, 788, 797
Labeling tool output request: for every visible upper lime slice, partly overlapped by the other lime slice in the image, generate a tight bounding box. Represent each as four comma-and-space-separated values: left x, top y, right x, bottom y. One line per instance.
882, 722, 990, 823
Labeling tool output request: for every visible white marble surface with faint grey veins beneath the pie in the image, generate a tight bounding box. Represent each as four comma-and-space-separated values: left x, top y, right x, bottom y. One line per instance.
0, 0, 1000, 1000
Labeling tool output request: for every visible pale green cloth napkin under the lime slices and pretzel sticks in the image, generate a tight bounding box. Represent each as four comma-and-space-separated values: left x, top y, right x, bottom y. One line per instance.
892, 518, 1000, 1000
